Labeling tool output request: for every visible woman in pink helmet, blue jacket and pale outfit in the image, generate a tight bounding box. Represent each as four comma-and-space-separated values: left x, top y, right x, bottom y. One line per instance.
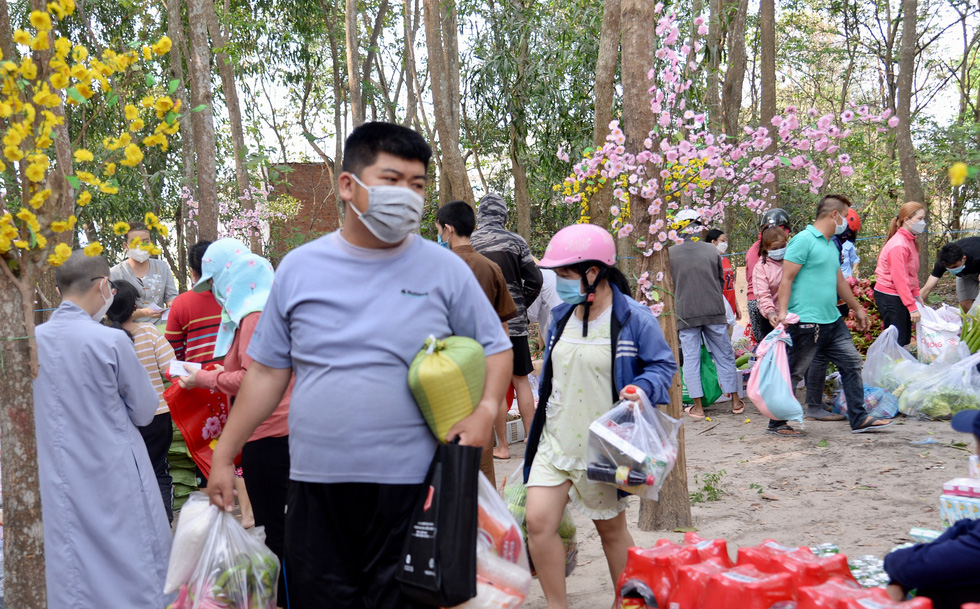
524, 224, 677, 609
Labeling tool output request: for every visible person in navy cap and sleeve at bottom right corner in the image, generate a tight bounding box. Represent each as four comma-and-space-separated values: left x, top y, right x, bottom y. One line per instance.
885, 410, 980, 609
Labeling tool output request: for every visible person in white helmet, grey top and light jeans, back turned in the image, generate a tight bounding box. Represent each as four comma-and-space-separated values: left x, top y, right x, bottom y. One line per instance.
667, 209, 745, 419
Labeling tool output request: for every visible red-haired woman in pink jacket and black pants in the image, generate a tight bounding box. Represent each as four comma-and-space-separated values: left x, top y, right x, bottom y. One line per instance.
875, 201, 926, 345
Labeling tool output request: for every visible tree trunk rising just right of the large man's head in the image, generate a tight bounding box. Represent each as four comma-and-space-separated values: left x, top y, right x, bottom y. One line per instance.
423, 0, 475, 205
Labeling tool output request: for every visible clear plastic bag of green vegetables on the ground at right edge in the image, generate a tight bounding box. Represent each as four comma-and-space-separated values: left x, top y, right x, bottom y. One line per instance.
899, 353, 980, 420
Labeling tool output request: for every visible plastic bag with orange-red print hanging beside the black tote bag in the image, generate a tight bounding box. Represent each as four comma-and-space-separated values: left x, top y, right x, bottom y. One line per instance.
450, 473, 531, 609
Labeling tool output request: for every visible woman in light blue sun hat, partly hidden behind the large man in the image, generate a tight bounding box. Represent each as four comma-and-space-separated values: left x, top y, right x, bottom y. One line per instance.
178, 239, 293, 600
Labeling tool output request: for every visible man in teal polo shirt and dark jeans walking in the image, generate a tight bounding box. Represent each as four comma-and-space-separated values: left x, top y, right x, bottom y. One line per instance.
766, 195, 891, 436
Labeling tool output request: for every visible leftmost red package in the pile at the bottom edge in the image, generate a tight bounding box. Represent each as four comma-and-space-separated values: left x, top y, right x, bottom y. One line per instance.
616, 539, 702, 609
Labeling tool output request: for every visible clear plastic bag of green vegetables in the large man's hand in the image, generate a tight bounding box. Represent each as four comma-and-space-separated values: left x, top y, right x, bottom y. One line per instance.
168, 490, 279, 609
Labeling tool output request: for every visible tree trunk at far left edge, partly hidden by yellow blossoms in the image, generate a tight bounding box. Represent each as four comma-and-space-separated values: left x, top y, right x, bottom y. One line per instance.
0, 0, 47, 609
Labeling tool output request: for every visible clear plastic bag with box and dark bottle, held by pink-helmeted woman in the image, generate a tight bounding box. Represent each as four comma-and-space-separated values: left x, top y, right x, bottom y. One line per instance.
586, 394, 681, 500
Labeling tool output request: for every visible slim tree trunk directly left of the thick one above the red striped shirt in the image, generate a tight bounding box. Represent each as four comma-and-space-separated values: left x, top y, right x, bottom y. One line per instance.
167, 0, 199, 248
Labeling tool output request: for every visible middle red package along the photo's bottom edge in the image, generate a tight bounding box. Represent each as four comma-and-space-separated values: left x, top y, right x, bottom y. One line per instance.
696, 565, 796, 609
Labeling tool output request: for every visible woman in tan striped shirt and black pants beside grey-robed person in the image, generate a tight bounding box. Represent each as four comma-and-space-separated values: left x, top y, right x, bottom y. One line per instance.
106, 281, 174, 522
